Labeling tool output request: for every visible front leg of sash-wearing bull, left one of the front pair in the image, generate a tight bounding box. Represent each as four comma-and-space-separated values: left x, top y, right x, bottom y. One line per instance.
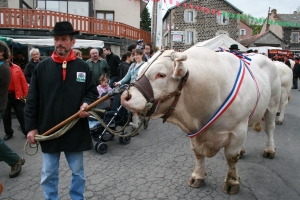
188, 151, 206, 188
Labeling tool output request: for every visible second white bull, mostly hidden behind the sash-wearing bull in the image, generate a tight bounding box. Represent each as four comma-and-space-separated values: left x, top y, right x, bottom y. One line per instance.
274, 61, 294, 125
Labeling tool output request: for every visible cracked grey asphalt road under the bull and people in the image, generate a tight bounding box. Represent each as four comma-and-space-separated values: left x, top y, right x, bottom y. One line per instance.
0, 90, 300, 200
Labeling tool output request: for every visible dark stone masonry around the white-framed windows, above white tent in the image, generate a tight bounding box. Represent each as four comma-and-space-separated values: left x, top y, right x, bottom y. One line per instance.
163, 0, 239, 50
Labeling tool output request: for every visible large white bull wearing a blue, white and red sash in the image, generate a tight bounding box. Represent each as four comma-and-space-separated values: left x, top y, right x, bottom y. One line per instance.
121, 47, 280, 194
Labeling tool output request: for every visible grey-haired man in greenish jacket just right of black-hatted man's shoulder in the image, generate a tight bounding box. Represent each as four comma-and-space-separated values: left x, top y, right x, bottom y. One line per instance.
86, 49, 110, 85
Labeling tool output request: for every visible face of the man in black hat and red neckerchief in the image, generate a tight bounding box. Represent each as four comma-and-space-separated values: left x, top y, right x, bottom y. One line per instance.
54, 35, 75, 56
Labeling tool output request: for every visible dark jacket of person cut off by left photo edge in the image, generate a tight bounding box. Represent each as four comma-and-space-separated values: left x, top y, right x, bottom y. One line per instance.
0, 59, 10, 111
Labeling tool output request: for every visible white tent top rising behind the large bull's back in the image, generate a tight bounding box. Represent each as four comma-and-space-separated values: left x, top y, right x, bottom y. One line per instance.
194, 34, 248, 52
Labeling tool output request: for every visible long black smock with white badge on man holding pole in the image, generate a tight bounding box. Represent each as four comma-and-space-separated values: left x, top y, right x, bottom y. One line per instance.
24, 58, 98, 153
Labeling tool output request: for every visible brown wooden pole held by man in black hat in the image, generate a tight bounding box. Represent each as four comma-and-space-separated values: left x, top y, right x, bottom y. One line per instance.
42, 94, 111, 136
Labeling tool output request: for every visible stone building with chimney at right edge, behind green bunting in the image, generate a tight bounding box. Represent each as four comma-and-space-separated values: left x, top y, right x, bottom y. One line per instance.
262, 9, 300, 53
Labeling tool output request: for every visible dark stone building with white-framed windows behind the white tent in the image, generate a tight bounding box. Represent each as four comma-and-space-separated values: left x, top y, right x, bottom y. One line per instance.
162, 0, 242, 50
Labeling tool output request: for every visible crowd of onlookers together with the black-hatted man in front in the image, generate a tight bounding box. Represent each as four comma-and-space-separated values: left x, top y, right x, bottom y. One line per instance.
0, 21, 159, 199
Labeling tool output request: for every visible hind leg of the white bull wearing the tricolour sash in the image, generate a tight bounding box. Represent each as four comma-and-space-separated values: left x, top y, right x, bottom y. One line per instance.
263, 109, 276, 159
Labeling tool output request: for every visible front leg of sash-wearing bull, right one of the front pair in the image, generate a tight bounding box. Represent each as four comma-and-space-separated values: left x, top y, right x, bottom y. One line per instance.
222, 144, 240, 194
